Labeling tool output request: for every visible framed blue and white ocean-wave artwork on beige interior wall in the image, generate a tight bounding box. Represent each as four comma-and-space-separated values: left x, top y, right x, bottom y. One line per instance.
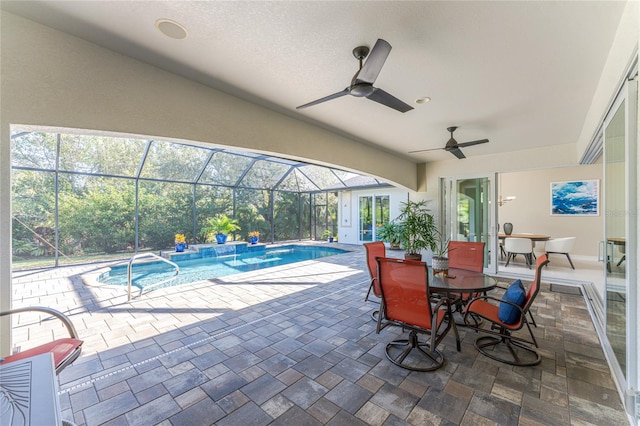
551, 179, 600, 216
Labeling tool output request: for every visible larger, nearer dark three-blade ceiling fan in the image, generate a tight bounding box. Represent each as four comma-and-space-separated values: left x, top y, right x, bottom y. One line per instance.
296, 38, 413, 112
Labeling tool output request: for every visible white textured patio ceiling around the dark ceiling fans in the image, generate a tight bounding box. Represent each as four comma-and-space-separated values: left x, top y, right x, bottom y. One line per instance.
1, 1, 625, 162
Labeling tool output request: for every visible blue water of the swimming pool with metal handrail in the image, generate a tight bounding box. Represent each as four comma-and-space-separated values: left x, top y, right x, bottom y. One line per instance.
98, 245, 347, 289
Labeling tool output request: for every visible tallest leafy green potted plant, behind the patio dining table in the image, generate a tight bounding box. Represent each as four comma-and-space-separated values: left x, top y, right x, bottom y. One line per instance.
396, 201, 438, 260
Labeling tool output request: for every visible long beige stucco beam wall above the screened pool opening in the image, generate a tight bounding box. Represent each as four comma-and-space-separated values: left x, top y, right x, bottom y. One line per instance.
1, 12, 416, 189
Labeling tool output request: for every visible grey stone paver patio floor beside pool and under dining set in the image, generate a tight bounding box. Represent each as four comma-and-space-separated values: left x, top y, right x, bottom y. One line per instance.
8, 246, 629, 426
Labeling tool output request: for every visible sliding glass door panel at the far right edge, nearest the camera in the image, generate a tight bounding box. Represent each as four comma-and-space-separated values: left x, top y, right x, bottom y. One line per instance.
603, 75, 638, 388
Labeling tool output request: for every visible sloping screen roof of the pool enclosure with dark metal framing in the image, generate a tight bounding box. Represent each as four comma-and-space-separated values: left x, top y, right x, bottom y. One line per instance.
11, 131, 388, 192
